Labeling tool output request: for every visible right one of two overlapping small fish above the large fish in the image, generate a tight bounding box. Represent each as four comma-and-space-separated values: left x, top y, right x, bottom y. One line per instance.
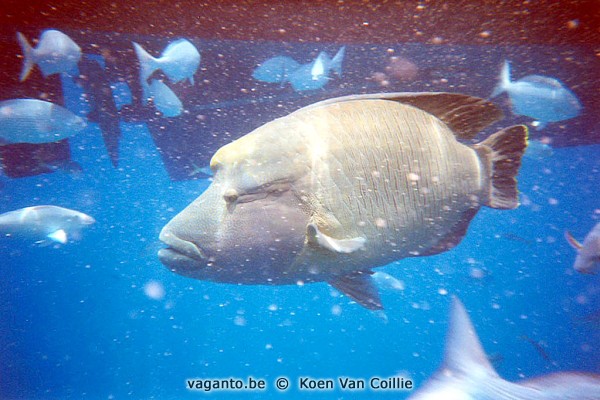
289, 47, 346, 92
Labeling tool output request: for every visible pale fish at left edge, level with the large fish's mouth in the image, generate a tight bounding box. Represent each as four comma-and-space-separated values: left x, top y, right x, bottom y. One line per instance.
0, 206, 96, 244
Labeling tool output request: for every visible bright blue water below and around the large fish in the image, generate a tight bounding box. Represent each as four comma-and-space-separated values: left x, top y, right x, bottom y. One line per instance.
0, 36, 600, 399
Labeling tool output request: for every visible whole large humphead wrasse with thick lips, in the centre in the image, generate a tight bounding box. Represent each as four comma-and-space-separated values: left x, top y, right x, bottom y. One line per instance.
159, 93, 526, 308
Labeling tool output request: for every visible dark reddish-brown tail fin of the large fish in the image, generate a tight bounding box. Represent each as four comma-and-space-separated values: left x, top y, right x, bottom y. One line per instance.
475, 125, 528, 210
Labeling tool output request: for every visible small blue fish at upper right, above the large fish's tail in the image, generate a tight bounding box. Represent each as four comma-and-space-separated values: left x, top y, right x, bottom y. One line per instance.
491, 61, 582, 129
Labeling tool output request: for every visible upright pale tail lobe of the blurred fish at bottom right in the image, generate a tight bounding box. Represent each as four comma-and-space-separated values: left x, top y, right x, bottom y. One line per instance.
443, 297, 498, 378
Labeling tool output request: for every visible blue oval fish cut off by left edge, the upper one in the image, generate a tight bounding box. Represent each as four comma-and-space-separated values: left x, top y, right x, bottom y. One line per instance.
0, 99, 87, 143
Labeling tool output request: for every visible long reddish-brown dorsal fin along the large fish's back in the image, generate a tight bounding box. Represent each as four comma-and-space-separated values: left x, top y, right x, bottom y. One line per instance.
309, 92, 503, 140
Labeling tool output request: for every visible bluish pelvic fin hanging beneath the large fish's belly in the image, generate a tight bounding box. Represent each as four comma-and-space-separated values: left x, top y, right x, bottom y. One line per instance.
329, 270, 383, 310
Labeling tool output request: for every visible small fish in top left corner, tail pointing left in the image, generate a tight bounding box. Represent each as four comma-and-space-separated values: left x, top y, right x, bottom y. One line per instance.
17, 29, 81, 82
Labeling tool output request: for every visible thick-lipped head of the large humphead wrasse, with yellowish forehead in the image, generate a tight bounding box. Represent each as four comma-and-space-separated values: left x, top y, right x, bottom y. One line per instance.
158, 120, 309, 284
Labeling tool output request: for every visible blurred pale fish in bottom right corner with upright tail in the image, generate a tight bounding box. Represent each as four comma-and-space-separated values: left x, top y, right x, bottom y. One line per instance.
409, 298, 600, 400
